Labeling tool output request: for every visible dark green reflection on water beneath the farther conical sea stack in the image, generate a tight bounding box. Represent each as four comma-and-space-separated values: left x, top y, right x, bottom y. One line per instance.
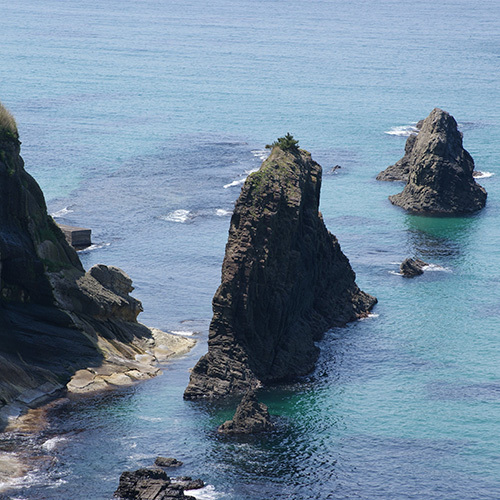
405, 214, 478, 259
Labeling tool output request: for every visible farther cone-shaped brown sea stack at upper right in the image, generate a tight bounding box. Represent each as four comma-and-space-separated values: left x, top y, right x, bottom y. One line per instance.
389, 108, 486, 215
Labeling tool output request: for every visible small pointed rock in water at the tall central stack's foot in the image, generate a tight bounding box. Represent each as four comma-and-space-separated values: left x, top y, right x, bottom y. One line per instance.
219, 390, 274, 434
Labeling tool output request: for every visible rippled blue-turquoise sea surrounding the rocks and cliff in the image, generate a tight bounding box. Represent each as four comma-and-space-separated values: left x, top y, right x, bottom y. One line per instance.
0, 0, 500, 500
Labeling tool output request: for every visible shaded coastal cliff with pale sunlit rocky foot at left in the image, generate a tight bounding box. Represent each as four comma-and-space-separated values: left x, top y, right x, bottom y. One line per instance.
0, 104, 193, 418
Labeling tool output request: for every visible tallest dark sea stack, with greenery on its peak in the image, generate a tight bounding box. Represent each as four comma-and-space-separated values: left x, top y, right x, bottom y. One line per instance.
184, 146, 376, 399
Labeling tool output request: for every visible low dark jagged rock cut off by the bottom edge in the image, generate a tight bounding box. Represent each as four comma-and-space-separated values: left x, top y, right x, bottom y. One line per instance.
115, 469, 196, 500
